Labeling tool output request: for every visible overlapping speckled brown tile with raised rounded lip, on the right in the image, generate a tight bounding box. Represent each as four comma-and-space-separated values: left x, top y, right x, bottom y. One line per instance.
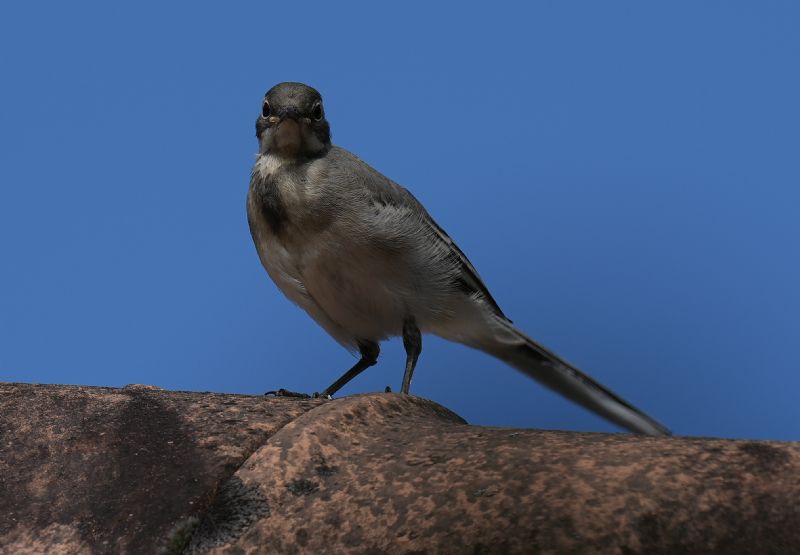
190, 394, 800, 554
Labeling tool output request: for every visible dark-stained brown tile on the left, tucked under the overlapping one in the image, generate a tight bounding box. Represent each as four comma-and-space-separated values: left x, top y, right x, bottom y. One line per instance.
0, 383, 322, 555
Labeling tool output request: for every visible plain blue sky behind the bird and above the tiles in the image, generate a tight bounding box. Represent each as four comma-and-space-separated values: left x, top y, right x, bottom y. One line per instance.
0, 1, 800, 439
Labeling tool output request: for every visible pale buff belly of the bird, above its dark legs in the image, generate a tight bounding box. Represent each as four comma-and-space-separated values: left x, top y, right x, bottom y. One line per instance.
254, 191, 484, 349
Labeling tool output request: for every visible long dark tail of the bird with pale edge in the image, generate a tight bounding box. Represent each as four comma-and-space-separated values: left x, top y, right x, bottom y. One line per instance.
479, 319, 672, 436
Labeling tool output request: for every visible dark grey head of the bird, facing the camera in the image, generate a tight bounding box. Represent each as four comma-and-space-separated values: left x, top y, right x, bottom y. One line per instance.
256, 83, 331, 159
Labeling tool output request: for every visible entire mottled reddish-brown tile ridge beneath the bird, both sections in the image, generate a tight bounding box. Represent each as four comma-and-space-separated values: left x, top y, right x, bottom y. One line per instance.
0, 384, 800, 554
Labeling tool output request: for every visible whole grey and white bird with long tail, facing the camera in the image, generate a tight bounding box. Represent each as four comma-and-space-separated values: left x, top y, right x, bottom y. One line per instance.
247, 82, 670, 435
